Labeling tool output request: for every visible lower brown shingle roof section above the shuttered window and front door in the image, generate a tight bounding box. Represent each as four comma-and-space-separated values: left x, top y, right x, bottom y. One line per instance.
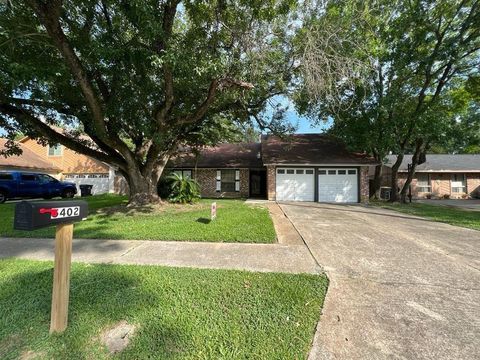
169, 143, 263, 168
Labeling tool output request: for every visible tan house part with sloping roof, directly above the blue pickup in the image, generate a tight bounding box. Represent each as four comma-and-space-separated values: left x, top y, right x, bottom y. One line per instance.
0, 139, 61, 178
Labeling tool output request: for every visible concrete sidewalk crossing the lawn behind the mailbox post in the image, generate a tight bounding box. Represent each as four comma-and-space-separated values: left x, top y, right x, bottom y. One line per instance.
0, 238, 321, 274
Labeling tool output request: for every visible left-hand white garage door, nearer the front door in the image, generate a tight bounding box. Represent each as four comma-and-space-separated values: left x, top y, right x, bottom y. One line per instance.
276, 168, 315, 201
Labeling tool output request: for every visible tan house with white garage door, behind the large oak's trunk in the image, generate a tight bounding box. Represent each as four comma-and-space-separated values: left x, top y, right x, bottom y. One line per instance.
19, 137, 116, 194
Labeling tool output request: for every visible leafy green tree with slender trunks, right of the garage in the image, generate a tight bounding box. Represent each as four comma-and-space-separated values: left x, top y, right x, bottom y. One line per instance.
297, 0, 480, 200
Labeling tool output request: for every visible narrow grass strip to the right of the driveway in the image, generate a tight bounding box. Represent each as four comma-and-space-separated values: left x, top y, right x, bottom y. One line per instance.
372, 202, 480, 230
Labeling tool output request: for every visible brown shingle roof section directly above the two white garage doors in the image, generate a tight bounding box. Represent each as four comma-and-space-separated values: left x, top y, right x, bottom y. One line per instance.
262, 134, 376, 165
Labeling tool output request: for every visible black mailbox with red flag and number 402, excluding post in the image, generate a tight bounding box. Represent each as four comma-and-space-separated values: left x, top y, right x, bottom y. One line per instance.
13, 200, 88, 230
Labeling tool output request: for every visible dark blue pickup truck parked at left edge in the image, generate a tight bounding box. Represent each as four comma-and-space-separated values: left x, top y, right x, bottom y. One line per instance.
0, 171, 77, 204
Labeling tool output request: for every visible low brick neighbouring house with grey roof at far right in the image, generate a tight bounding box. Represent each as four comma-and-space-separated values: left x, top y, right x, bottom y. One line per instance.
382, 154, 480, 199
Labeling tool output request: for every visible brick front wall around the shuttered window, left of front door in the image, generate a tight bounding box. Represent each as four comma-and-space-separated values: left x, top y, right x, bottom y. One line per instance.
193, 169, 250, 198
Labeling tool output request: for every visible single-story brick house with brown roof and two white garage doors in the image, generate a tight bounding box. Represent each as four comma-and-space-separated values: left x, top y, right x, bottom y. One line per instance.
168, 134, 376, 202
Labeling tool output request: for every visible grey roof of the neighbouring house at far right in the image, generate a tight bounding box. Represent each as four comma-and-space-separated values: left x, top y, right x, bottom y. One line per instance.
385, 154, 480, 172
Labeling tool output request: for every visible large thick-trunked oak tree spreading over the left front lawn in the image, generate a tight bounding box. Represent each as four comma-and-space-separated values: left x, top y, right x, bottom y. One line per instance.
0, 0, 295, 203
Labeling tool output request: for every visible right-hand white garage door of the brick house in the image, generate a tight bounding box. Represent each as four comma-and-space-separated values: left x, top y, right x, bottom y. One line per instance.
318, 168, 358, 202
